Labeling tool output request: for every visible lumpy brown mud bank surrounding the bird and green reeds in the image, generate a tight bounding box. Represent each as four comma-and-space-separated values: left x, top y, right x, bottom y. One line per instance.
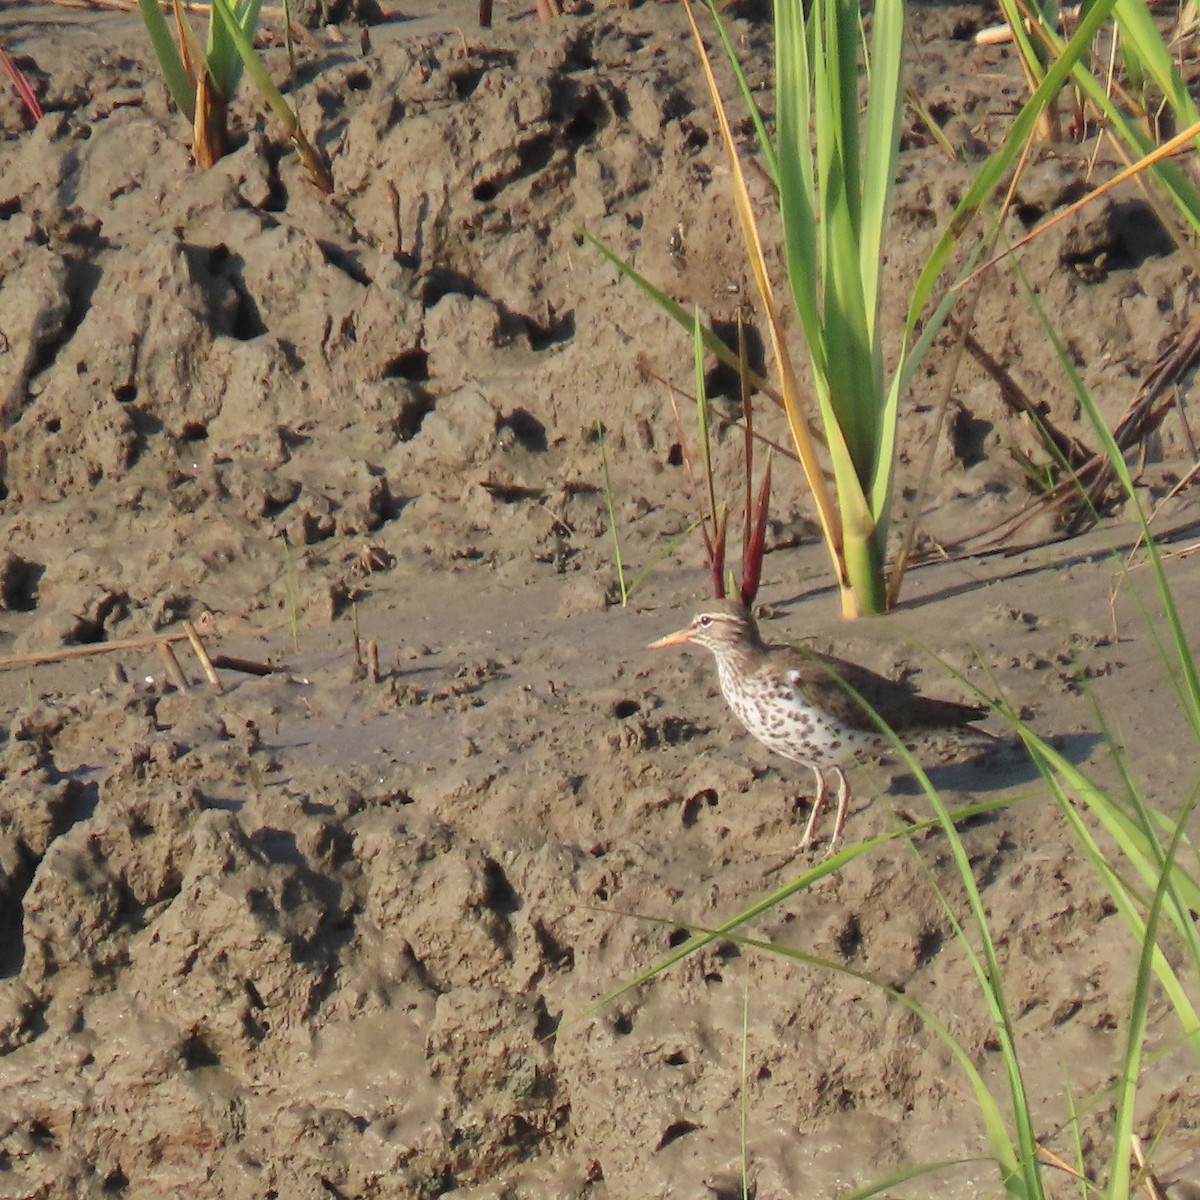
0, 5, 1200, 1200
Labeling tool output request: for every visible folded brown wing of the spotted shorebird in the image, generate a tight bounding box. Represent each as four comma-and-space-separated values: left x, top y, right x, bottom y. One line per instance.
792, 647, 988, 733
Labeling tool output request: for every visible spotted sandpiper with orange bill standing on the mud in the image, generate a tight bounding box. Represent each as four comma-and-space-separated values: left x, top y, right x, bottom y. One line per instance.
648, 601, 989, 854
